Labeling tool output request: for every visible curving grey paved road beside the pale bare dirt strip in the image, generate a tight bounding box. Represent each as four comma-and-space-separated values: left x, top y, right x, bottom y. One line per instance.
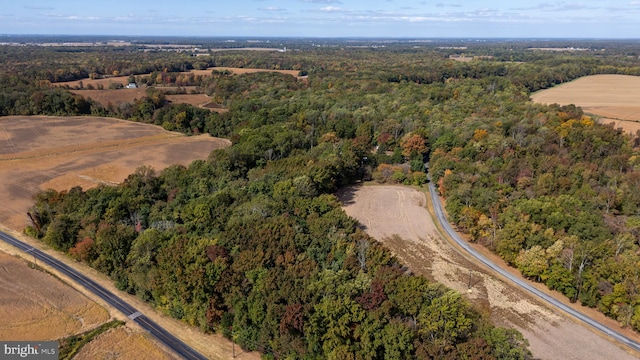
429, 177, 640, 351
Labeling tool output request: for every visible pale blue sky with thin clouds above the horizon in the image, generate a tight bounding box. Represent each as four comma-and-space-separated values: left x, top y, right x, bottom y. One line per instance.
0, 0, 640, 38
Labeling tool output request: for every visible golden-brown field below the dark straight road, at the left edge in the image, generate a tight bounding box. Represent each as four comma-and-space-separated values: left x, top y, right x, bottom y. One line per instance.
0, 252, 110, 341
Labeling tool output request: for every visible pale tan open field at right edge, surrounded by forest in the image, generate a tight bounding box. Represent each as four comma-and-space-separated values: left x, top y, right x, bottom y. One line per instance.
531, 75, 640, 133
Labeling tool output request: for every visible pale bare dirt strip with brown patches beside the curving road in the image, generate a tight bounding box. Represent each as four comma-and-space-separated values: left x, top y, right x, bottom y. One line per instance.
339, 186, 638, 359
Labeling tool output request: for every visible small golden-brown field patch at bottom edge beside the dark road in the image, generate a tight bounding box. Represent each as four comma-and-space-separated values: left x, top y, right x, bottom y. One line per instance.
73, 326, 178, 360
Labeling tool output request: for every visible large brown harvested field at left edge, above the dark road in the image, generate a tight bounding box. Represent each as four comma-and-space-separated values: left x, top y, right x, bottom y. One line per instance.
0, 116, 231, 231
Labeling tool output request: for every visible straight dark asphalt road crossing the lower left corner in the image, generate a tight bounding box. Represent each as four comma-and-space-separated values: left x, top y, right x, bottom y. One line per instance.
0, 231, 207, 360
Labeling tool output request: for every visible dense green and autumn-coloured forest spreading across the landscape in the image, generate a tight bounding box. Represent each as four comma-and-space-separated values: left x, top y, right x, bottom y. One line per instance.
0, 38, 640, 359
